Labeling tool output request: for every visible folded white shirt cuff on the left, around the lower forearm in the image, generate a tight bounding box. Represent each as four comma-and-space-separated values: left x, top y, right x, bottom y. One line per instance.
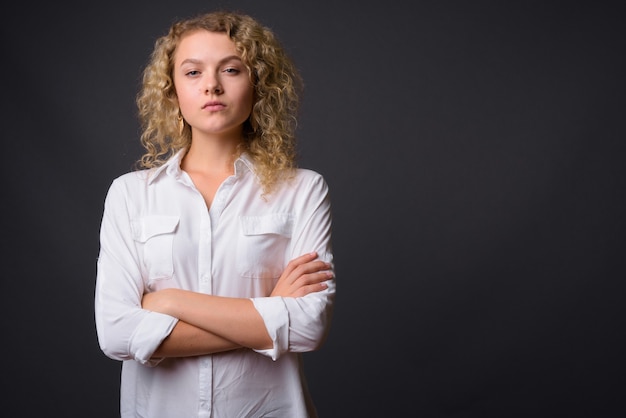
129, 312, 178, 367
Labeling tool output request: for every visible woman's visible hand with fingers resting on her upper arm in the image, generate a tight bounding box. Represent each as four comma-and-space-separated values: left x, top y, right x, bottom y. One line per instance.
270, 252, 334, 298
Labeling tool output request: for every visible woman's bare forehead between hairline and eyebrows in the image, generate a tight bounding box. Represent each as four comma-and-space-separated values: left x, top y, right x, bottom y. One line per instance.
174, 29, 239, 63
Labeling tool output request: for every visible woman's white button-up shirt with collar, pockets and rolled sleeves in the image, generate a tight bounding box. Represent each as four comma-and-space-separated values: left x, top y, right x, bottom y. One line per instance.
95, 151, 335, 418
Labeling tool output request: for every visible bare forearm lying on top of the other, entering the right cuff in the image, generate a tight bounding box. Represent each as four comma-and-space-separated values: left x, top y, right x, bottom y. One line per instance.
144, 289, 272, 351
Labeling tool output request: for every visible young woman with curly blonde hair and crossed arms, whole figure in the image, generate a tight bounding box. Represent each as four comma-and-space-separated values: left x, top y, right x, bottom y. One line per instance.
95, 12, 335, 418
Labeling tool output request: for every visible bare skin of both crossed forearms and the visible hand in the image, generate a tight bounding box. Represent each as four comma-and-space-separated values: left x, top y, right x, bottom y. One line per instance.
142, 253, 332, 358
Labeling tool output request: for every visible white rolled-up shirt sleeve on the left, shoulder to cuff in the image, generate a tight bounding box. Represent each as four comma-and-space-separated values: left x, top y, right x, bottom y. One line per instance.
94, 180, 178, 366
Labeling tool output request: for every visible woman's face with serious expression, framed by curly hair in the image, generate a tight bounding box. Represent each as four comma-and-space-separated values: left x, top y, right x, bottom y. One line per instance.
174, 30, 254, 140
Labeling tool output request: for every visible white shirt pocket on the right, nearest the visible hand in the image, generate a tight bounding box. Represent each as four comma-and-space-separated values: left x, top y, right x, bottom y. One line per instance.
237, 213, 293, 279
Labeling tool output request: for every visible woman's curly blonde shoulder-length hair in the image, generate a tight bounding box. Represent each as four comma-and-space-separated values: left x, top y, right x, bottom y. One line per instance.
137, 11, 302, 193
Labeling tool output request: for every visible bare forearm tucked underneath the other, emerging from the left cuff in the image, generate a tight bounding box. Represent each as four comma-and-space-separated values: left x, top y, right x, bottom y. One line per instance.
152, 320, 241, 358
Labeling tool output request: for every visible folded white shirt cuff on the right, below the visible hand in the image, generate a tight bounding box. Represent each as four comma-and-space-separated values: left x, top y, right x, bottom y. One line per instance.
250, 296, 289, 361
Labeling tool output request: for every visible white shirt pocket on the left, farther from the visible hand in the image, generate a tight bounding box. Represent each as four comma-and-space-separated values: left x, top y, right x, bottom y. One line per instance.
130, 215, 179, 282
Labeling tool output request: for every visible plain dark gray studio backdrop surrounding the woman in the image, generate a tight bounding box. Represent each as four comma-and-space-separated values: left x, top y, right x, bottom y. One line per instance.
0, 0, 626, 418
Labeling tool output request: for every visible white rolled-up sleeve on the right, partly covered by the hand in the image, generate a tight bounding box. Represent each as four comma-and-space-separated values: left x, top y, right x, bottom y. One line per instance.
252, 172, 336, 360
